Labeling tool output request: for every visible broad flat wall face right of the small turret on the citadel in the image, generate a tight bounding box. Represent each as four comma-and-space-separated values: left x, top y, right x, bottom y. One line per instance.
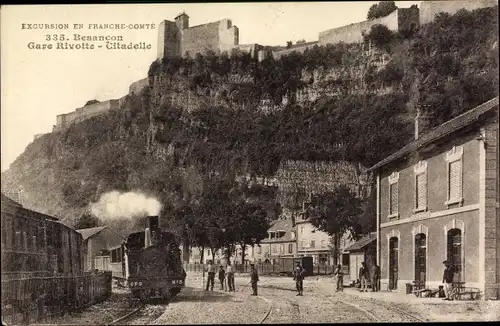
181, 22, 220, 58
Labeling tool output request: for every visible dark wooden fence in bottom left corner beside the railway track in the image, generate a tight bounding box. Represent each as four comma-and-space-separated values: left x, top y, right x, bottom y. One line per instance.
2, 272, 112, 325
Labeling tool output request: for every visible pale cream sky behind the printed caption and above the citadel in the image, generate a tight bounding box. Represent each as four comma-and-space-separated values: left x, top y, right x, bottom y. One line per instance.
0, 1, 420, 172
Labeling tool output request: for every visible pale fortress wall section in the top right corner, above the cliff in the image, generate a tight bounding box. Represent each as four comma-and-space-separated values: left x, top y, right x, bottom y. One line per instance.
420, 0, 498, 25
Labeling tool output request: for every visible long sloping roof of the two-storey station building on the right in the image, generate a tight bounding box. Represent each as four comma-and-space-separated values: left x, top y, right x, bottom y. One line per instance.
368, 96, 498, 171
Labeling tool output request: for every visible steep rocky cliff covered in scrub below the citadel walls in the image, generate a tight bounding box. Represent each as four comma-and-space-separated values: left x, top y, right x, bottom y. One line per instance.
2, 7, 498, 224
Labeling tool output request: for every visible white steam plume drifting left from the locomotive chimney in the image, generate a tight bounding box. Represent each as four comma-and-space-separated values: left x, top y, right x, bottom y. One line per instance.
90, 191, 161, 220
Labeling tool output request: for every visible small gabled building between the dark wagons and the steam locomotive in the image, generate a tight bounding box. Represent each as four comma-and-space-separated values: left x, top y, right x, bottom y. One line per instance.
76, 226, 125, 271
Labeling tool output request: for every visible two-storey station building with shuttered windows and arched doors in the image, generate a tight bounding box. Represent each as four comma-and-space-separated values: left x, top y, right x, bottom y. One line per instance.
370, 97, 500, 299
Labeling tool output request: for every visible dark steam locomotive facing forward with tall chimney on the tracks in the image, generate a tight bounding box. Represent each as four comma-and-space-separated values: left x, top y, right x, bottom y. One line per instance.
122, 216, 186, 301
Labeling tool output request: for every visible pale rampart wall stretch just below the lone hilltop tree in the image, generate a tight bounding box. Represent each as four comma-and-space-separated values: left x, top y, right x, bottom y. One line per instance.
319, 10, 398, 45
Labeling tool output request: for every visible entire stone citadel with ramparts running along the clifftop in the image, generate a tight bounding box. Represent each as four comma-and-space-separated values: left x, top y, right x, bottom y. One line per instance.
48, 0, 498, 134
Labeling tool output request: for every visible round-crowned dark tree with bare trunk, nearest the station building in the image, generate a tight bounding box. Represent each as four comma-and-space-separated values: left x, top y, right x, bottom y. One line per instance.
307, 185, 363, 265
